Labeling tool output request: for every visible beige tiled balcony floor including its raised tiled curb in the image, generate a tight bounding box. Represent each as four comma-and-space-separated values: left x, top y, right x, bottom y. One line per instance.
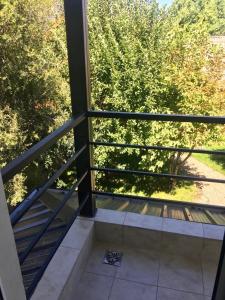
32, 209, 224, 300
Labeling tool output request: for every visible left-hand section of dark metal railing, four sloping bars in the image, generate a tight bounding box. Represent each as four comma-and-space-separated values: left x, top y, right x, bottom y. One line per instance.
1, 114, 91, 297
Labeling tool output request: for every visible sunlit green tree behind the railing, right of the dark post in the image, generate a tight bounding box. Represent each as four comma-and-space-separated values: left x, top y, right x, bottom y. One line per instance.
89, 0, 224, 195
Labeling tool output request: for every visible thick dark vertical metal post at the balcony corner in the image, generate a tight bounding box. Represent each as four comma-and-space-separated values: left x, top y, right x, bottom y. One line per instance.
64, 0, 96, 217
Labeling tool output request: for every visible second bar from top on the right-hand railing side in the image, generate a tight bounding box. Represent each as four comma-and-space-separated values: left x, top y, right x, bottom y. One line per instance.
90, 142, 225, 155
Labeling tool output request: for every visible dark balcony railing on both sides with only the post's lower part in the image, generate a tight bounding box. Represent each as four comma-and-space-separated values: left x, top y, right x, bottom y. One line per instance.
2, 111, 225, 297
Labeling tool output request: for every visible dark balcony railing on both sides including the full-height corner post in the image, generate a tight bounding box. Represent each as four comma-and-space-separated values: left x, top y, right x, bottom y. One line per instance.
1, 0, 225, 299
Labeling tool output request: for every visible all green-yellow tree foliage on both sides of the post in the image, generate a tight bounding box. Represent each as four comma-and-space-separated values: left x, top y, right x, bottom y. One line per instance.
0, 0, 225, 203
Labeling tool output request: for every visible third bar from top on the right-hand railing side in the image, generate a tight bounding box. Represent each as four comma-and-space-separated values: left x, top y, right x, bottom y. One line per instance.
91, 167, 225, 183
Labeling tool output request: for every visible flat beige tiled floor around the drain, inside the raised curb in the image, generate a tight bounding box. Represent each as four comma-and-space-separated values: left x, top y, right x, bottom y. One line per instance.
74, 242, 214, 300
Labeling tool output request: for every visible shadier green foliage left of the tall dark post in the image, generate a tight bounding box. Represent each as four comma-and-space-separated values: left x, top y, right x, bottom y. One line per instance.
0, 0, 70, 203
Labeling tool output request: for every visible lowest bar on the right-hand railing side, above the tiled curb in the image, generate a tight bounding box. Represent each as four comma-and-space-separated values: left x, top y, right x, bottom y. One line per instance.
92, 191, 225, 210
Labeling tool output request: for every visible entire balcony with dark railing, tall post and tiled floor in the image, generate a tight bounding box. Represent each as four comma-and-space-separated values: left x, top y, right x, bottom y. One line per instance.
0, 0, 225, 300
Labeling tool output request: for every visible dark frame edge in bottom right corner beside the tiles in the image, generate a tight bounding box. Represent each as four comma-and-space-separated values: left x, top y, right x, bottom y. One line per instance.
212, 234, 225, 300
